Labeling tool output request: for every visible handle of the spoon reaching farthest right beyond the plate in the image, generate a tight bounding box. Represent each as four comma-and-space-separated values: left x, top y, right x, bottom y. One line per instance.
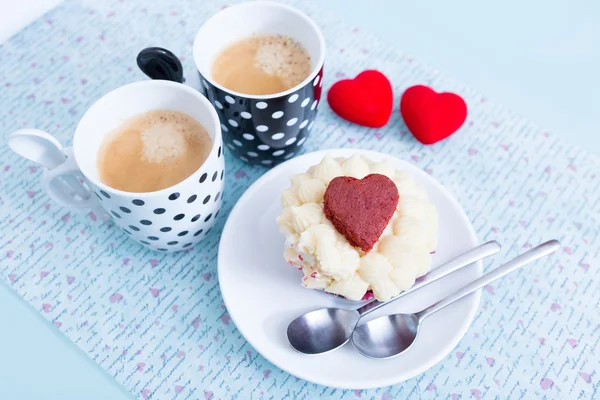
417, 240, 560, 320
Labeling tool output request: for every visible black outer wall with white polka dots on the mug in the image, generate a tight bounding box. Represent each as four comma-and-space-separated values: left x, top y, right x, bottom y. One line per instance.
200, 68, 323, 165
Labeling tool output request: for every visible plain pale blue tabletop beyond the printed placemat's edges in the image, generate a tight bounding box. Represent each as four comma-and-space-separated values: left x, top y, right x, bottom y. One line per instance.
0, 0, 600, 400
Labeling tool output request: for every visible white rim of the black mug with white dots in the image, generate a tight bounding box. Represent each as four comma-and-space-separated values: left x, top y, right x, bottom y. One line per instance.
192, 0, 325, 100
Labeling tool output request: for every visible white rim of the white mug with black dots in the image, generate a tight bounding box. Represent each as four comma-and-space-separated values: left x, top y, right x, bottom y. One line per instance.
72, 80, 223, 198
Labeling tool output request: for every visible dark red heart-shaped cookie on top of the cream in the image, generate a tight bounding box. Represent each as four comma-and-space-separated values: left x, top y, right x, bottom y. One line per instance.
323, 174, 400, 253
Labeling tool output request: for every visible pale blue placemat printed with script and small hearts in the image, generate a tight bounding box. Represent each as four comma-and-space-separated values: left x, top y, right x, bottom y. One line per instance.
0, 0, 600, 400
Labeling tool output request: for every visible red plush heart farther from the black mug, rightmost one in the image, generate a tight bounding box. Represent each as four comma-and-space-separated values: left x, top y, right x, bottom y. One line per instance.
400, 85, 467, 144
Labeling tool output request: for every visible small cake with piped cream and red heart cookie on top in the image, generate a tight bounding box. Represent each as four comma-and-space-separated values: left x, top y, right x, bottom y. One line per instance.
277, 154, 438, 301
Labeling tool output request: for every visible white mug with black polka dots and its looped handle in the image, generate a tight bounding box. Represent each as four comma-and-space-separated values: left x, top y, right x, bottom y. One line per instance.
24, 80, 225, 252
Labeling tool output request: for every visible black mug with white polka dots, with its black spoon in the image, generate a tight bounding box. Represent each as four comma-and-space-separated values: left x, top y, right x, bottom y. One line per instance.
138, 1, 325, 166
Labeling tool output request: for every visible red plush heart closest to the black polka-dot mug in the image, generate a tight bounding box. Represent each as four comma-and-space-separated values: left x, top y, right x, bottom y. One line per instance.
327, 70, 394, 128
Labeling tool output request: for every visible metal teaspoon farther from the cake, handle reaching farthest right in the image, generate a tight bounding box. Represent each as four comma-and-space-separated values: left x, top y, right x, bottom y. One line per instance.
352, 240, 560, 358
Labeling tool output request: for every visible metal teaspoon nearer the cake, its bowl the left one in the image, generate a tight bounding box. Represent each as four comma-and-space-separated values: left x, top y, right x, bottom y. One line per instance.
287, 241, 500, 355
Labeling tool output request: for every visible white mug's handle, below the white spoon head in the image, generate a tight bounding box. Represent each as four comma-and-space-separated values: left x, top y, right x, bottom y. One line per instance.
42, 147, 100, 210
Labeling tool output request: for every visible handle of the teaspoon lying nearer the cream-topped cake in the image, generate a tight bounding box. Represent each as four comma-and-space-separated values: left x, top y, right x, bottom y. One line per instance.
356, 240, 500, 316
